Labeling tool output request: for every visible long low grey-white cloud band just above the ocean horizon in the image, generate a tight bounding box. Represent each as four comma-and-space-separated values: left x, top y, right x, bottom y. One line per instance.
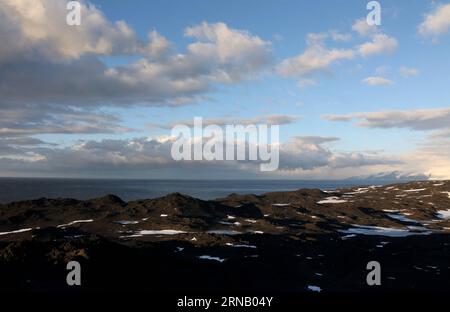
0, 137, 398, 178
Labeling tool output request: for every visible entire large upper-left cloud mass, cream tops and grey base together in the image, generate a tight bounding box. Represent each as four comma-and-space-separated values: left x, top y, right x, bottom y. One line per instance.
0, 0, 272, 106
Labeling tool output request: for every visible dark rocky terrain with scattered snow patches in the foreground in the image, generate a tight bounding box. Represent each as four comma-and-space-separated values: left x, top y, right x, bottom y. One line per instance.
0, 181, 450, 293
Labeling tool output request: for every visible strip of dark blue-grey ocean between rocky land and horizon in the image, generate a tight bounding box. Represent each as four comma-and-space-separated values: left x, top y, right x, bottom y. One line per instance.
0, 178, 398, 203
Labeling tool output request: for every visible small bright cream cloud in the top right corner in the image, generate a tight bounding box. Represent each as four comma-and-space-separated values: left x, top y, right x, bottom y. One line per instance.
418, 4, 450, 37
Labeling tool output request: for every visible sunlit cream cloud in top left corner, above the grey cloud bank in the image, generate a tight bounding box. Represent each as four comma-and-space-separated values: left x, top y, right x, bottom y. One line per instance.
0, 0, 141, 63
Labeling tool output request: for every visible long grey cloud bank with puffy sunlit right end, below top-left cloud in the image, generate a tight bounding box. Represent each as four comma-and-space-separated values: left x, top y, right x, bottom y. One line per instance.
0, 18, 271, 106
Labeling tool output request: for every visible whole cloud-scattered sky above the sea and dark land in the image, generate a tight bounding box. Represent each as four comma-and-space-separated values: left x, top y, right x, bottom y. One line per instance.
0, 0, 450, 179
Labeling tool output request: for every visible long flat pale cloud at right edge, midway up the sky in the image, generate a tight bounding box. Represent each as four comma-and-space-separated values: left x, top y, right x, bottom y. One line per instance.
323, 108, 450, 131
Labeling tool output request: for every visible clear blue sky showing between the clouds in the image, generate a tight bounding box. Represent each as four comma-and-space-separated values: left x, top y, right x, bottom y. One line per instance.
93, 0, 450, 151
